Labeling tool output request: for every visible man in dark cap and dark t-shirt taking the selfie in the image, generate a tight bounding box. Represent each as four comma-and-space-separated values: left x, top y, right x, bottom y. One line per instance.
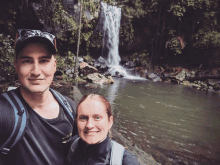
0, 29, 76, 165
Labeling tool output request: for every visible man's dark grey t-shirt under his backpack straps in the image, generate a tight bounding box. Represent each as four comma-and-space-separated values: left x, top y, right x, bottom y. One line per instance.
0, 89, 76, 165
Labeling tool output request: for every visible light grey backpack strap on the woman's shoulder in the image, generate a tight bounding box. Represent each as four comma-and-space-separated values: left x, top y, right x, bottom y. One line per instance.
110, 141, 125, 165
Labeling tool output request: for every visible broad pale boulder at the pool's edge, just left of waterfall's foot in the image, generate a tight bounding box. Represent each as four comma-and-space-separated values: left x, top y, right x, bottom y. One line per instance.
87, 73, 109, 84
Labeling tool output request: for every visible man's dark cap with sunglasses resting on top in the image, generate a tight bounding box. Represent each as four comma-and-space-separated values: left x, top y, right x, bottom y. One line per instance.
15, 29, 56, 55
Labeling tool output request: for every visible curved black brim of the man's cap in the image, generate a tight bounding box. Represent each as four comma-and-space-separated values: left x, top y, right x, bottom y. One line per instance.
15, 36, 56, 56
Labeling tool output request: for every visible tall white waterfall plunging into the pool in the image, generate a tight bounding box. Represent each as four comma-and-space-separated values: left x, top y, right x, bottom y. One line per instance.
101, 2, 145, 79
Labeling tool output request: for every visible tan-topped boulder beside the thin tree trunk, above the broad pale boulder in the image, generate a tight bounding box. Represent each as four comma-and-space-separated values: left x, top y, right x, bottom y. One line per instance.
79, 62, 98, 77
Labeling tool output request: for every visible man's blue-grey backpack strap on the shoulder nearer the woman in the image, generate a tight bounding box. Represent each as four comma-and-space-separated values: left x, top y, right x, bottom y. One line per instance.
50, 88, 74, 123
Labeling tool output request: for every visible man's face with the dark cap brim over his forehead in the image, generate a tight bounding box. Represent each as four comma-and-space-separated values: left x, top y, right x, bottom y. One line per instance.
15, 43, 56, 93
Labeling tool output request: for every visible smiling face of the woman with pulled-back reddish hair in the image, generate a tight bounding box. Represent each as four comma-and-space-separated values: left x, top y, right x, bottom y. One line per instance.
77, 96, 113, 145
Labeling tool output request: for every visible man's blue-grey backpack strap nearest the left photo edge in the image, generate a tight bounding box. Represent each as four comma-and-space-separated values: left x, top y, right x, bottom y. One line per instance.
0, 90, 27, 154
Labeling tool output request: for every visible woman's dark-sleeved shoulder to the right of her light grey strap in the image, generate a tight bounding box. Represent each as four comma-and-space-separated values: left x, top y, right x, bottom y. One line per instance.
122, 149, 140, 165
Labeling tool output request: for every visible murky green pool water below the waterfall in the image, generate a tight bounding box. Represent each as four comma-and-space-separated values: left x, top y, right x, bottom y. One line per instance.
59, 79, 220, 164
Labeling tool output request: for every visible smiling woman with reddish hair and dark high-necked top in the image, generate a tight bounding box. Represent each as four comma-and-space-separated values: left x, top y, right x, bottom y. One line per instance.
66, 94, 139, 165
